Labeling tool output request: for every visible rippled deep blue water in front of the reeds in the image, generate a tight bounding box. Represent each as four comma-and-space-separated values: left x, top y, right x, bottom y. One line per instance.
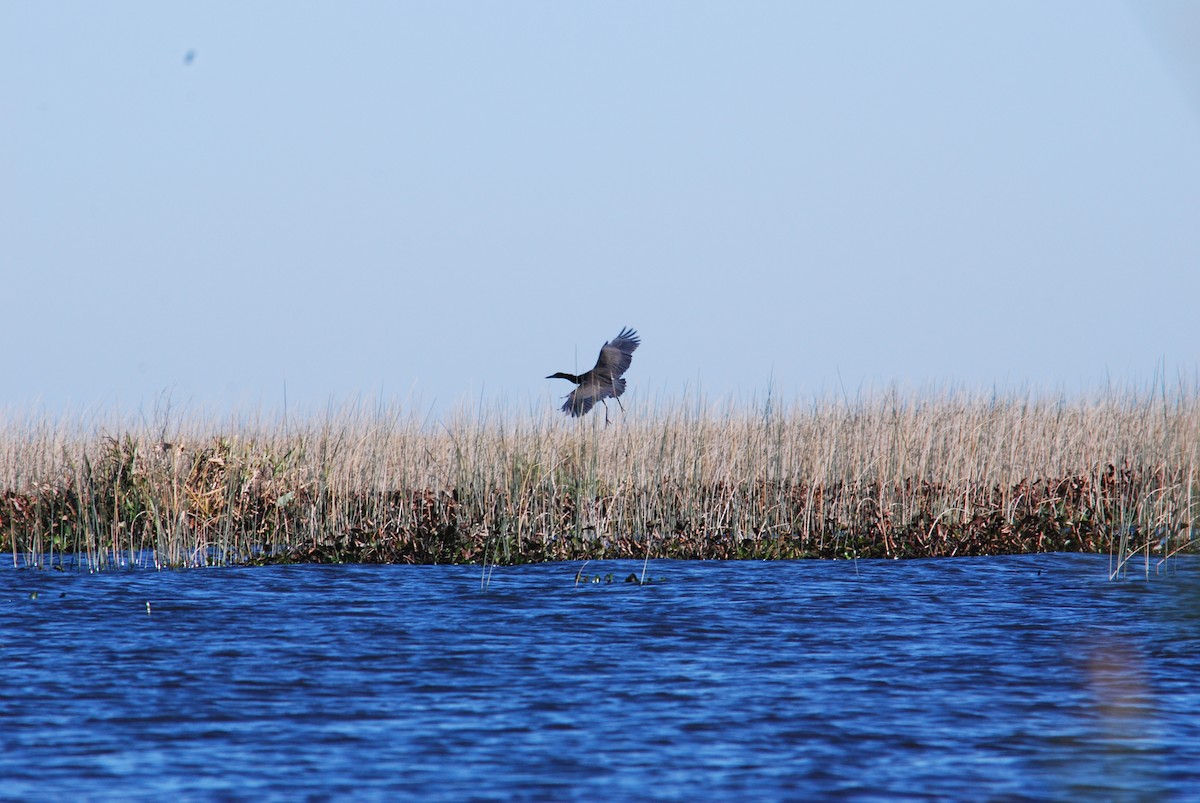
0, 555, 1200, 801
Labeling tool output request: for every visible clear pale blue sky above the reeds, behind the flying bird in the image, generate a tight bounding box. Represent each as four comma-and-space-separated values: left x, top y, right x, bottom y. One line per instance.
0, 0, 1200, 420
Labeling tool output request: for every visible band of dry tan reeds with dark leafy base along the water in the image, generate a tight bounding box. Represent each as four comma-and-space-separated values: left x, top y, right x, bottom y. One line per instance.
0, 384, 1200, 570
